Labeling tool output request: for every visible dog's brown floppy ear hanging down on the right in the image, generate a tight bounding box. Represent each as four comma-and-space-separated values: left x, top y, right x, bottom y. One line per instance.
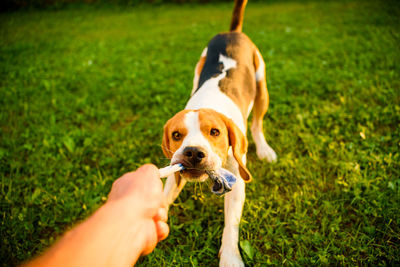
220, 116, 252, 182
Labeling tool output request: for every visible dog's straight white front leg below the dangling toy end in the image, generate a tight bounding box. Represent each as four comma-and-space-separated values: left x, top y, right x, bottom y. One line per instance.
219, 174, 245, 267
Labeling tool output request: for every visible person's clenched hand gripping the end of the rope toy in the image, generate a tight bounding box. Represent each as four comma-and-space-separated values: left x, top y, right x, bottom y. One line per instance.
107, 164, 169, 255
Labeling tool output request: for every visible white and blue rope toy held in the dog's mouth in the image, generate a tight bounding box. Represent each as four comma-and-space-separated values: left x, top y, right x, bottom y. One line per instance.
158, 163, 236, 196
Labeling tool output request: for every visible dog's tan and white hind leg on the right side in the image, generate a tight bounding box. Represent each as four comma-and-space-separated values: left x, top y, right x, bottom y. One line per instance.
251, 49, 277, 162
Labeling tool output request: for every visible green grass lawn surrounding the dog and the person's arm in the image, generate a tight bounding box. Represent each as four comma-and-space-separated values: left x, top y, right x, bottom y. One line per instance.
0, 1, 400, 266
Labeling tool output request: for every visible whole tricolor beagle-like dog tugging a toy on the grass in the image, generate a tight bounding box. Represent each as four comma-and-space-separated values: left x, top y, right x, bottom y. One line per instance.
162, 0, 276, 266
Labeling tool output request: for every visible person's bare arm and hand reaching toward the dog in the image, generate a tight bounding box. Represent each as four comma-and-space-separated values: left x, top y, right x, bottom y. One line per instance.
25, 164, 169, 267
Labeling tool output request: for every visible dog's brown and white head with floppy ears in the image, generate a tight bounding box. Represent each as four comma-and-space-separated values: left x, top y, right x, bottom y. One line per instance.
162, 109, 251, 181
